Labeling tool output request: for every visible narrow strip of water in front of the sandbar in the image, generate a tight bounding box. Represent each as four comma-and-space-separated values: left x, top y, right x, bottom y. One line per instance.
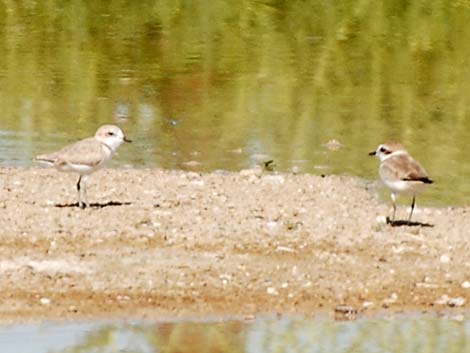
0, 317, 470, 353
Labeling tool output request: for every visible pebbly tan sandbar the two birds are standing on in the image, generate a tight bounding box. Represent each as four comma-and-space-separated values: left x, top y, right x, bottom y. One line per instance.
0, 168, 470, 322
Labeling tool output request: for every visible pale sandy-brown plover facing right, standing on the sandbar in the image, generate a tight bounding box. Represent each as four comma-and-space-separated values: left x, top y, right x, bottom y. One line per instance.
35, 125, 132, 208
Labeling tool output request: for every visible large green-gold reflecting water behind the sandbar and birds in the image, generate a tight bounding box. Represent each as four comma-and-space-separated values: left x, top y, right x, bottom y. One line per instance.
0, 0, 470, 204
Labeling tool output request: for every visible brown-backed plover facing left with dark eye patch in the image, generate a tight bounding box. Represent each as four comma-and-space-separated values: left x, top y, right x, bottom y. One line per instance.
369, 142, 433, 221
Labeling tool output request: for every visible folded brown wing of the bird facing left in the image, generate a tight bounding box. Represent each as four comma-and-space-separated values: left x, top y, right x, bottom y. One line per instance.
380, 154, 430, 182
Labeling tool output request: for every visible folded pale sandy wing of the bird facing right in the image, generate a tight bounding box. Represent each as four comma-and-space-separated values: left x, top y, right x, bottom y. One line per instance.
49, 137, 104, 166
